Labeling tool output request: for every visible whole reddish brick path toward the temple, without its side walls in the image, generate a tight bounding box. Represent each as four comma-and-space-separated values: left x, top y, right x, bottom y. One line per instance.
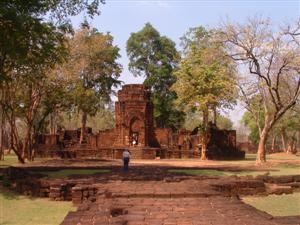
62, 170, 300, 225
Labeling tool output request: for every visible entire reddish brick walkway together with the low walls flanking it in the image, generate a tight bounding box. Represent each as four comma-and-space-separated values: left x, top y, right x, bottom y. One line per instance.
5, 166, 300, 225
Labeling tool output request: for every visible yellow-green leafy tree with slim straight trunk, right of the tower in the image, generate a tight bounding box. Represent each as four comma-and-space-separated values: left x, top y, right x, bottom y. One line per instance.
172, 27, 236, 159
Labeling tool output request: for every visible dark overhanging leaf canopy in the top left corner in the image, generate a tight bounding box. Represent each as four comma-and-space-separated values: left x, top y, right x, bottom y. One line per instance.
0, 0, 103, 81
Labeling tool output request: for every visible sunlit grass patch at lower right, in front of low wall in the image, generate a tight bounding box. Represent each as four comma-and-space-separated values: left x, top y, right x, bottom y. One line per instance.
243, 192, 300, 216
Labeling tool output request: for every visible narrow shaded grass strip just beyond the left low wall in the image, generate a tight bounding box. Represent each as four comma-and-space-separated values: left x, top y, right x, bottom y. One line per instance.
37, 169, 110, 178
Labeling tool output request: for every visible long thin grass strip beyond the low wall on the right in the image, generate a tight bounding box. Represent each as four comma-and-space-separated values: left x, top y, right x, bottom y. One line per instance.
169, 163, 300, 176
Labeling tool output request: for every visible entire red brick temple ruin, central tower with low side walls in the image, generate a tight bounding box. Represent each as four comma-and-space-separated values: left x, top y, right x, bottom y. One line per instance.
35, 84, 245, 159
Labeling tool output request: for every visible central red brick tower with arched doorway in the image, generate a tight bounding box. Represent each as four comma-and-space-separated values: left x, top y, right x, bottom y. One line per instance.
114, 84, 153, 147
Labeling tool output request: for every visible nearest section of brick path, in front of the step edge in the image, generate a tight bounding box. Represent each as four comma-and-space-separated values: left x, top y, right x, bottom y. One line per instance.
62, 196, 297, 225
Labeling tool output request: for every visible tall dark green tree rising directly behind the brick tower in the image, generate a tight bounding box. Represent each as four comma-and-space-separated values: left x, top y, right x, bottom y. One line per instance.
126, 23, 183, 129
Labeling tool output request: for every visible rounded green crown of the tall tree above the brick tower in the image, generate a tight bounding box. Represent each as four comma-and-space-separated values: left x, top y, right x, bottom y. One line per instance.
126, 23, 179, 79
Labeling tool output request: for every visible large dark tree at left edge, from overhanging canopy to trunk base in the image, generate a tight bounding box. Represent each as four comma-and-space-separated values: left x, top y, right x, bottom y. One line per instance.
0, 0, 103, 163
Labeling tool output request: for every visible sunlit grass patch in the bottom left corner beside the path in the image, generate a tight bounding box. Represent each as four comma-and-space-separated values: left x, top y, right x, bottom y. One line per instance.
0, 189, 76, 225
